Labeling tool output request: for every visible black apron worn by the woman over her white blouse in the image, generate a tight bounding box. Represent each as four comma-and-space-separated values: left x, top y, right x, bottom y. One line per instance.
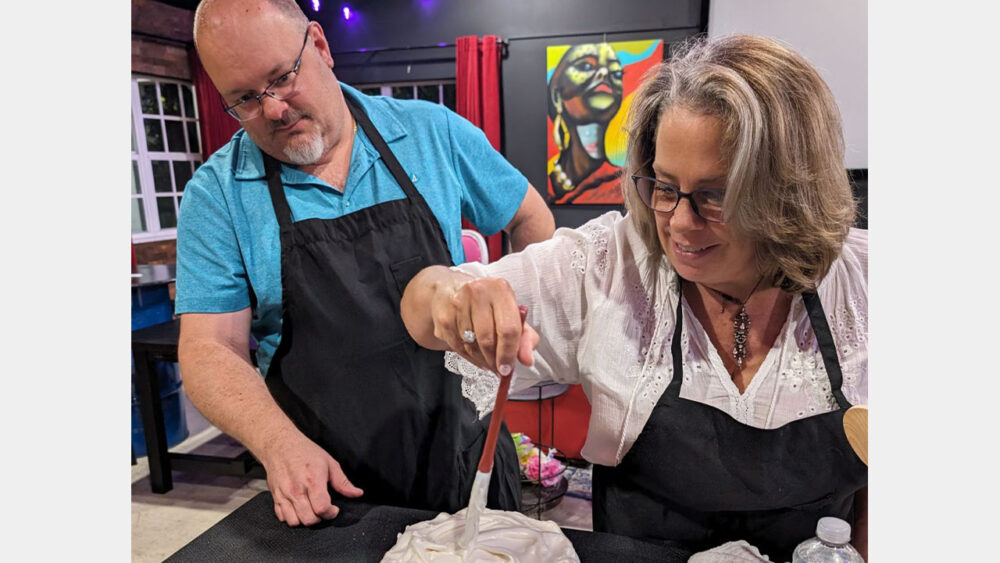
593, 293, 868, 561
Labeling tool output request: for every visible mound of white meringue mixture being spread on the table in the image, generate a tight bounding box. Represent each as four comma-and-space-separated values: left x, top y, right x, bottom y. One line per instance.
382, 508, 580, 563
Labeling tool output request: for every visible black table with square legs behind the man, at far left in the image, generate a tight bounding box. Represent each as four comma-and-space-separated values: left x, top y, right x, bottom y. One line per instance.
132, 319, 266, 493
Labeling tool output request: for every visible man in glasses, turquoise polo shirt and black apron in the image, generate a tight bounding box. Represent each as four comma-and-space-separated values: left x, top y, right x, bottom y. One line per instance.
176, 0, 554, 526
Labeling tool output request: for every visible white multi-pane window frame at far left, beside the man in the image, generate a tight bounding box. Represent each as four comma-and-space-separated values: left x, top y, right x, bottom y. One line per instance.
129, 74, 203, 243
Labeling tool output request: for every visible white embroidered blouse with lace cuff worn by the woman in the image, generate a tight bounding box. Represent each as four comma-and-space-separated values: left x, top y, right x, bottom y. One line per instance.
447, 211, 868, 465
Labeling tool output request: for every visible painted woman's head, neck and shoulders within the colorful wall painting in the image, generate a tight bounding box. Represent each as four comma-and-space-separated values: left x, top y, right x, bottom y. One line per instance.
549, 43, 623, 203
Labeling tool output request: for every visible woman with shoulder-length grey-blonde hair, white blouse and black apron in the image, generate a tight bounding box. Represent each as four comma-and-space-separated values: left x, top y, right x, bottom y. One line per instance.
402, 36, 868, 561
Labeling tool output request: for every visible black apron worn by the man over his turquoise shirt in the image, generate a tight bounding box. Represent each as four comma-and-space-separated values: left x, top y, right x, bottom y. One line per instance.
264, 94, 521, 512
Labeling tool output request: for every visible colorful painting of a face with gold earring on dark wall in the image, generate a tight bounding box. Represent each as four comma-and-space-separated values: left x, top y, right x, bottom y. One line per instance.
546, 39, 663, 205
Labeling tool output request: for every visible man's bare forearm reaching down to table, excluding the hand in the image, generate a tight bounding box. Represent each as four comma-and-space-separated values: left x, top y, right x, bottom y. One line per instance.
178, 341, 299, 465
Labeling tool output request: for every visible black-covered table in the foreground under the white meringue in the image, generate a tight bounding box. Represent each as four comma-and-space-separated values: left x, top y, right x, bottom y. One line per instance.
166, 492, 692, 563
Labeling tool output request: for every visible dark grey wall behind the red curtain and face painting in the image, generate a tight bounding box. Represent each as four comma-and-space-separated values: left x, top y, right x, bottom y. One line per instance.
308, 0, 708, 227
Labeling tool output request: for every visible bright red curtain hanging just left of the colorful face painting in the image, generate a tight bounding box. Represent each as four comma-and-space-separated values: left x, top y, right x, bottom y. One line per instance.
455, 35, 503, 262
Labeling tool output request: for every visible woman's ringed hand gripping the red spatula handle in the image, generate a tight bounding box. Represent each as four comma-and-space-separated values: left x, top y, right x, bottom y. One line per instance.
401, 266, 538, 375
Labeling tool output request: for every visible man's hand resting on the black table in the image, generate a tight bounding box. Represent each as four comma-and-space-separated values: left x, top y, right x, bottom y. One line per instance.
261, 432, 364, 526
